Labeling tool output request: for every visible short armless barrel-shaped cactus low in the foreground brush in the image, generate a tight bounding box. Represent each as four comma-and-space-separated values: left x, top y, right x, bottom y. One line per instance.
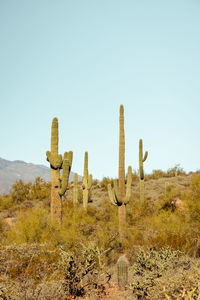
117, 255, 128, 289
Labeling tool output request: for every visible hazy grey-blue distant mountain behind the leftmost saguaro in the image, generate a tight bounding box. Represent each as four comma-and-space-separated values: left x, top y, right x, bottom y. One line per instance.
0, 158, 81, 194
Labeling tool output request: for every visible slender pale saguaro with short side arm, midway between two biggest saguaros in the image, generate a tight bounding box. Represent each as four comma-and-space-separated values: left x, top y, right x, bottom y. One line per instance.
82, 152, 92, 210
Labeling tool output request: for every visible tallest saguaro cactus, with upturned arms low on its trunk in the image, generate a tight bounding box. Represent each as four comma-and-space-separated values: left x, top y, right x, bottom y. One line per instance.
108, 105, 132, 238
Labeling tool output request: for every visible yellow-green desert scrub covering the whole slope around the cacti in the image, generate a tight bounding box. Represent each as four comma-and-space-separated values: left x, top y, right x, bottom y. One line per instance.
0, 172, 200, 299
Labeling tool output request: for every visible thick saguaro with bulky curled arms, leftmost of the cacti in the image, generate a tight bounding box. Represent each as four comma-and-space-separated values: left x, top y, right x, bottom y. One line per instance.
46, 118, 73, 223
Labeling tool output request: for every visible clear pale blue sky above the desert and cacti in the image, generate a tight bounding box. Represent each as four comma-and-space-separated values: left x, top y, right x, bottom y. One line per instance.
0, 0, 200, 179
